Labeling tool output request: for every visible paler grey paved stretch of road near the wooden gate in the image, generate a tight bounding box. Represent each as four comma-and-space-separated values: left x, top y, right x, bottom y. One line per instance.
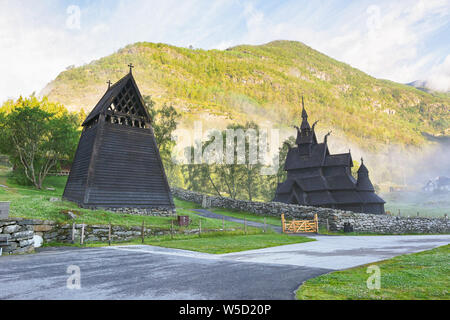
222, 235, 450, 270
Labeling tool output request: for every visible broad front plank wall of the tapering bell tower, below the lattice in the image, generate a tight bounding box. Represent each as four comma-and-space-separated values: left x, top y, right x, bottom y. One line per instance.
86, 123, 173, 208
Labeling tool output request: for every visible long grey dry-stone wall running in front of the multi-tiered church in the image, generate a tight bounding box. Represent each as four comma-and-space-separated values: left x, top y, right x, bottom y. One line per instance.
172, 188, 450, 234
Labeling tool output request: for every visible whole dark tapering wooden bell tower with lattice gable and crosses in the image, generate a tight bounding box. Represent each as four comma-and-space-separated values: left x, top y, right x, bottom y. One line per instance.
63, 65, 174, 212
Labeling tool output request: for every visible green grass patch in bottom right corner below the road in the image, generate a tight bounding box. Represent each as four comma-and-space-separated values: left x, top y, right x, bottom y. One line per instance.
296, 245, 450, 300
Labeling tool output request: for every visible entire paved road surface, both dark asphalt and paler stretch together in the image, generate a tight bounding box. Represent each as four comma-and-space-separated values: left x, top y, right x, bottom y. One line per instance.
0, 235, 450, 300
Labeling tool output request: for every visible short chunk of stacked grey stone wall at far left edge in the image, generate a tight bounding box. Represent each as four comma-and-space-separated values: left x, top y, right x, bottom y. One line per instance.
0, 218, 34, 254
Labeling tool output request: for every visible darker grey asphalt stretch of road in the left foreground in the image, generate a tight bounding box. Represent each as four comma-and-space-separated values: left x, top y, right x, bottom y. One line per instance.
0, 246, 329, 300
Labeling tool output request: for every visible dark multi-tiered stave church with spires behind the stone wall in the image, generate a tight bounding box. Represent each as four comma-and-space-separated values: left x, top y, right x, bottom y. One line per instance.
273, 101, 385, 214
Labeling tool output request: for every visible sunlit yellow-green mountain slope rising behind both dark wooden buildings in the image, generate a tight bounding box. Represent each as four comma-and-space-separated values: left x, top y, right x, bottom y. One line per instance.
43, 41, 450, 149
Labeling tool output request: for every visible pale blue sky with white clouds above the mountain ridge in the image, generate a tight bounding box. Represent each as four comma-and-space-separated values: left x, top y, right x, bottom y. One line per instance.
0, 0, 450, 103
